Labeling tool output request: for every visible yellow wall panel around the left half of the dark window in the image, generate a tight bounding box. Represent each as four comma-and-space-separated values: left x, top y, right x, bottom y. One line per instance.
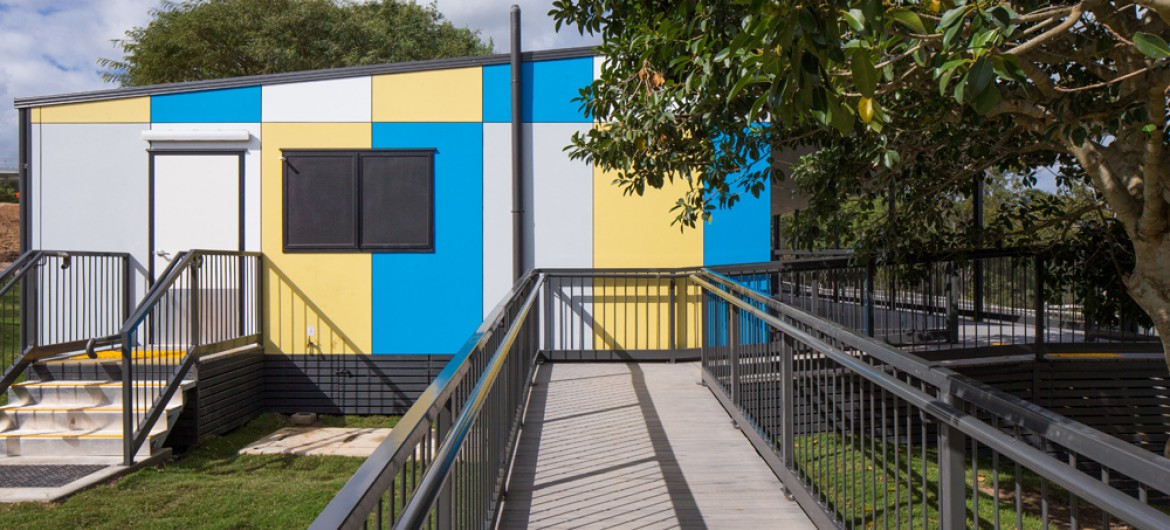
261, 123, 373, 353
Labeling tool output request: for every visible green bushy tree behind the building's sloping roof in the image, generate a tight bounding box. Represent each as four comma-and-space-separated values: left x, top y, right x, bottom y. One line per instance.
98, 0, 491, 85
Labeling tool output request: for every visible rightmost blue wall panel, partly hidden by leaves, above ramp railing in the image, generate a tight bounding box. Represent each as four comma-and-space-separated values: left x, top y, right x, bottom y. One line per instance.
703, 152, 772, 266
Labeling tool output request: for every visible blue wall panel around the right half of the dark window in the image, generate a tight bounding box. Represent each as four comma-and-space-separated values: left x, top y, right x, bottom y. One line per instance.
372, 123, 483, 353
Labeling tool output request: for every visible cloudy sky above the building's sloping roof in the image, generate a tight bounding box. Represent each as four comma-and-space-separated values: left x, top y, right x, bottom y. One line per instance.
0, 0, 599, 167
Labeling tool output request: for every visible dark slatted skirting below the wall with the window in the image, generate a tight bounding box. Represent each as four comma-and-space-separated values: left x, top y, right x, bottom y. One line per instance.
264, 353, 450, 414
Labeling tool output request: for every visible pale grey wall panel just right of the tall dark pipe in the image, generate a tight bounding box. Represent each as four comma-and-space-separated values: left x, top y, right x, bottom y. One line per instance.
524, 123, 593, 268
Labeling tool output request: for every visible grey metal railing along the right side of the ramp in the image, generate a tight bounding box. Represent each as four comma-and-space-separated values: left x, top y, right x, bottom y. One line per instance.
691, 271, 1170, 529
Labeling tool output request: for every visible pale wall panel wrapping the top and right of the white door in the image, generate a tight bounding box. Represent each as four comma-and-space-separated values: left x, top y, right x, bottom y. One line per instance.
151, 123, 261, 252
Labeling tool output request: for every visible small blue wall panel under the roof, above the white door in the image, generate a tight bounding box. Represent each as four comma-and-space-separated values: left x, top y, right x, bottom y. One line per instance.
150, 87, 261, 123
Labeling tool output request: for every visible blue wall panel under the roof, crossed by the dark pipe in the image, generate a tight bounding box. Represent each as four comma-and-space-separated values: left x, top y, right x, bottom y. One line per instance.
483, 57, 593, 123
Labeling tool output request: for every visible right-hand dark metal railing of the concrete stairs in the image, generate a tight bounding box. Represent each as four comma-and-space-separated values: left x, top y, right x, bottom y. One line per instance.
121, 250, 262, 466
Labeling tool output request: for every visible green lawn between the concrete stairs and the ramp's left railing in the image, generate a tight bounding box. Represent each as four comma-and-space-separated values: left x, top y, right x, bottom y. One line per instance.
0, 413, 398, 529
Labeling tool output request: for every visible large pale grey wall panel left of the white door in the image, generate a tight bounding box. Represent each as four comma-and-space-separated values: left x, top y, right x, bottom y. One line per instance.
34, 124, 150, 301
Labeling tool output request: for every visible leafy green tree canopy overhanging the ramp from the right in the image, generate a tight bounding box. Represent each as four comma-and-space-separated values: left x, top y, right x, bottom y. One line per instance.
552, 0, 1170, 372
